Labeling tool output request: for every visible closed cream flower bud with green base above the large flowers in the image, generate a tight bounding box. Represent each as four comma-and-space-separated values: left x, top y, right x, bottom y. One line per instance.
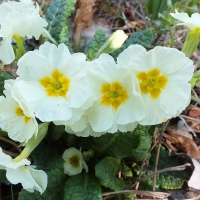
98, 30, 128, 55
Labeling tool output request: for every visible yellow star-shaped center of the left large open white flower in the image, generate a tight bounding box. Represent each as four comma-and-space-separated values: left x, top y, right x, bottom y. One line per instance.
40, 69, 70, 98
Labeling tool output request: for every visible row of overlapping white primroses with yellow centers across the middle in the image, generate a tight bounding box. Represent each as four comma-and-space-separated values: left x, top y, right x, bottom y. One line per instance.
0, 42, 194, 139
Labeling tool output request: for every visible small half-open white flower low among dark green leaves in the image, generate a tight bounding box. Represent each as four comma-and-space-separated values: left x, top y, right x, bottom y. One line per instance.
62, 147, 88, 176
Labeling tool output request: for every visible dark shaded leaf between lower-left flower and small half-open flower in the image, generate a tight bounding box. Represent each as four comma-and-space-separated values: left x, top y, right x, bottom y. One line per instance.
31, 142, 64, 172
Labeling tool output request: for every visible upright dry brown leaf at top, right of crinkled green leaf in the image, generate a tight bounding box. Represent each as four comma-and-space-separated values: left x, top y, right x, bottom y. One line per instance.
74, 0, 96, 44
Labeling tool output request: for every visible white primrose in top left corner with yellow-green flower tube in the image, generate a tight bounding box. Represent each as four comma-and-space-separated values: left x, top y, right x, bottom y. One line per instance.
0, 2, 48, 64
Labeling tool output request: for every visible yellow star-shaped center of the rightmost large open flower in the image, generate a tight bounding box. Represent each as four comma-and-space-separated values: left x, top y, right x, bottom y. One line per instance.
137, 68, 168, 99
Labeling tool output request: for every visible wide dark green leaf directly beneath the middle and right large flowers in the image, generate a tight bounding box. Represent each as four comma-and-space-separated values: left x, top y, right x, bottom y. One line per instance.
81, 125, 151, 161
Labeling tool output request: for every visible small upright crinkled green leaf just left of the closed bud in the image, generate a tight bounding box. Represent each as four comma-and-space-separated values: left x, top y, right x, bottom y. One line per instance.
86, 29, 106, 60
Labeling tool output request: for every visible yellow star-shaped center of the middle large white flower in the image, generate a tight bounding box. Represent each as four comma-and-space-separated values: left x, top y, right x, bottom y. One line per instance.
101, 82, 129, 110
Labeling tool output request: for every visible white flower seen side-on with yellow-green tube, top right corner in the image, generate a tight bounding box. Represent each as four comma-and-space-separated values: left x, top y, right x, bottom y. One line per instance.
170, 11, 200, 57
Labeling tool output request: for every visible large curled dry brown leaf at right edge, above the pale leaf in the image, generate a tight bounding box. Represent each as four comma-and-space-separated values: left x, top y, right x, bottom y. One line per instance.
163, 133, 200, 162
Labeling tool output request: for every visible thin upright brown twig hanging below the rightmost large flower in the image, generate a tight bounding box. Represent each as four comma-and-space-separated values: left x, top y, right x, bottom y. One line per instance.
153, 120, 169, 191
